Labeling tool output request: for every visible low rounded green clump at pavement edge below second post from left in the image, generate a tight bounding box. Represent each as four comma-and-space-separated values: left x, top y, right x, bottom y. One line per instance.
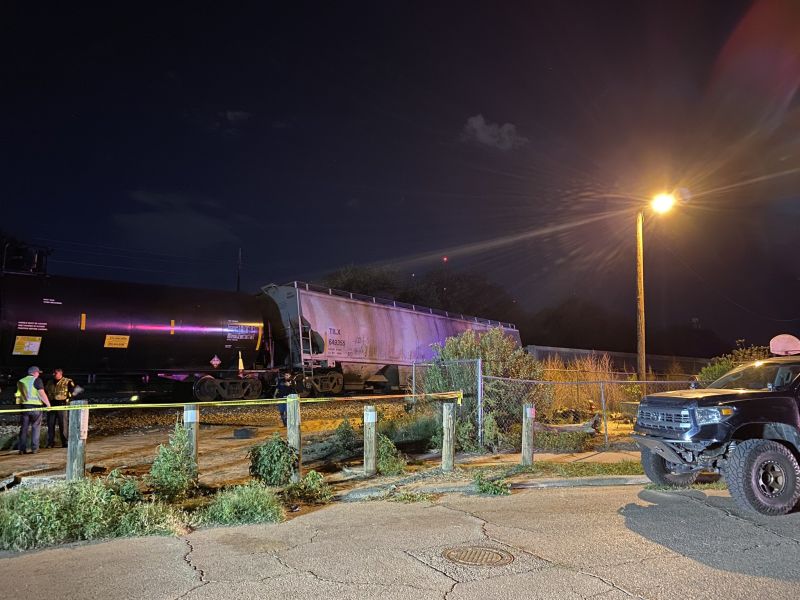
198, 481, 284, 525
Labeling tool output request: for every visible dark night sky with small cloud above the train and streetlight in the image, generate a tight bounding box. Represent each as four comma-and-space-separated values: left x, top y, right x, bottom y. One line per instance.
0, 0, 800, 342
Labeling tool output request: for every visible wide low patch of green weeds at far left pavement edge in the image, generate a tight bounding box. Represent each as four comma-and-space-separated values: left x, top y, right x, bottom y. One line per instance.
0, 479, 185, 550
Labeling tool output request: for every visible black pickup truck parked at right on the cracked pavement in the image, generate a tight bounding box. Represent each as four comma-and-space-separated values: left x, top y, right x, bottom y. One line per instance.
634, 356, 800, 515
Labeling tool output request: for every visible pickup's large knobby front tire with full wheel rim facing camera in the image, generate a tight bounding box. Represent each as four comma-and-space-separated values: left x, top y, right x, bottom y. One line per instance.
725, 440, 800, 515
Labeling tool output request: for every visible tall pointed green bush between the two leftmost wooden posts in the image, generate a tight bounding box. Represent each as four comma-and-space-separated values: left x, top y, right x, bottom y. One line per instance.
146, 423, 198, 501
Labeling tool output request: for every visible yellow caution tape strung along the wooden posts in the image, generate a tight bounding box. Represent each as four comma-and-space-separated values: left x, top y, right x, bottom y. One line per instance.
0, 391, 464, 414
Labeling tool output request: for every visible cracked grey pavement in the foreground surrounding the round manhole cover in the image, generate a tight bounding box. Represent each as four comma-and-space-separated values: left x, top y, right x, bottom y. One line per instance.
0, 486, 800, 600
